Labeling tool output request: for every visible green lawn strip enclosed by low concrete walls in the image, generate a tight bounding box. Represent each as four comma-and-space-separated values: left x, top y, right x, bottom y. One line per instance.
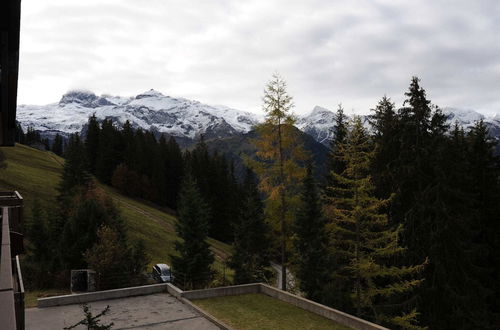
193, 293, 350, 330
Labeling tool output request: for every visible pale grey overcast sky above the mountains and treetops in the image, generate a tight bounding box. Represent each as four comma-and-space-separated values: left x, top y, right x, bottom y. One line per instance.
19, 0, 500, 114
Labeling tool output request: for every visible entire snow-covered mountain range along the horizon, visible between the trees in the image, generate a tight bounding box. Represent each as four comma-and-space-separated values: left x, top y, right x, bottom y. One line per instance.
17, 90, 500, 146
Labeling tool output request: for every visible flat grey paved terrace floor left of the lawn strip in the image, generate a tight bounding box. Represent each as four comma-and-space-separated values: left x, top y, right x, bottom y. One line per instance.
26, 293, 219, 330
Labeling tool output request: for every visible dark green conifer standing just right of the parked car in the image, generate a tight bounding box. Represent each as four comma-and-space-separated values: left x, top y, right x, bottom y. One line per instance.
171, 175, 214, 289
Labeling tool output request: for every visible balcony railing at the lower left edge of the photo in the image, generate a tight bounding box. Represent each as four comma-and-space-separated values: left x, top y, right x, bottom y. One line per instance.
0, 192, 24, 330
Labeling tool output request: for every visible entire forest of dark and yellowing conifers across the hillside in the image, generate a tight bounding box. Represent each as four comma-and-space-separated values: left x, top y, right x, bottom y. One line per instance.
4, 76, 500, 329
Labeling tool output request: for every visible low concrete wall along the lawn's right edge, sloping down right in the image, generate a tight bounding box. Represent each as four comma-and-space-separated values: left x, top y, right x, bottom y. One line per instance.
260, 284, 388, 330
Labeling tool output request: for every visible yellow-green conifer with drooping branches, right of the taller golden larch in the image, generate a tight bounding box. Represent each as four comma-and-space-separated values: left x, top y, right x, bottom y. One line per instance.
325, 117, 423, 328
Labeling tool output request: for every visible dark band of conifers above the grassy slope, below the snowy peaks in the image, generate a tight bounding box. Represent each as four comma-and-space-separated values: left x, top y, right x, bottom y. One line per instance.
85, 116, 246, 242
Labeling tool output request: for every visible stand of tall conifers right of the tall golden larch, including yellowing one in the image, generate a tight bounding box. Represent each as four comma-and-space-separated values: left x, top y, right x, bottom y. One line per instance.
296, 78, 500, 329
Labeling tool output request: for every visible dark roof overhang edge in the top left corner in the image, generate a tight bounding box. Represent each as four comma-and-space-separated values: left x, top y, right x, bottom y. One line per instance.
0, 0, 21, 146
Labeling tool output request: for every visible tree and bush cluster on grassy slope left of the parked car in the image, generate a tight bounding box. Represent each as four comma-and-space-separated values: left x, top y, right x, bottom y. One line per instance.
23, 134, 149, 289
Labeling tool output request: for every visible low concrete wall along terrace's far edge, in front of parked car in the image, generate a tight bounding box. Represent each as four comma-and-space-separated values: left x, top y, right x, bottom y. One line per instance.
38, 283, 168, 308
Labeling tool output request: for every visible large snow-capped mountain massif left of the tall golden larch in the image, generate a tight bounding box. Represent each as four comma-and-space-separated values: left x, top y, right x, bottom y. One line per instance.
17, 90, 260, 139
